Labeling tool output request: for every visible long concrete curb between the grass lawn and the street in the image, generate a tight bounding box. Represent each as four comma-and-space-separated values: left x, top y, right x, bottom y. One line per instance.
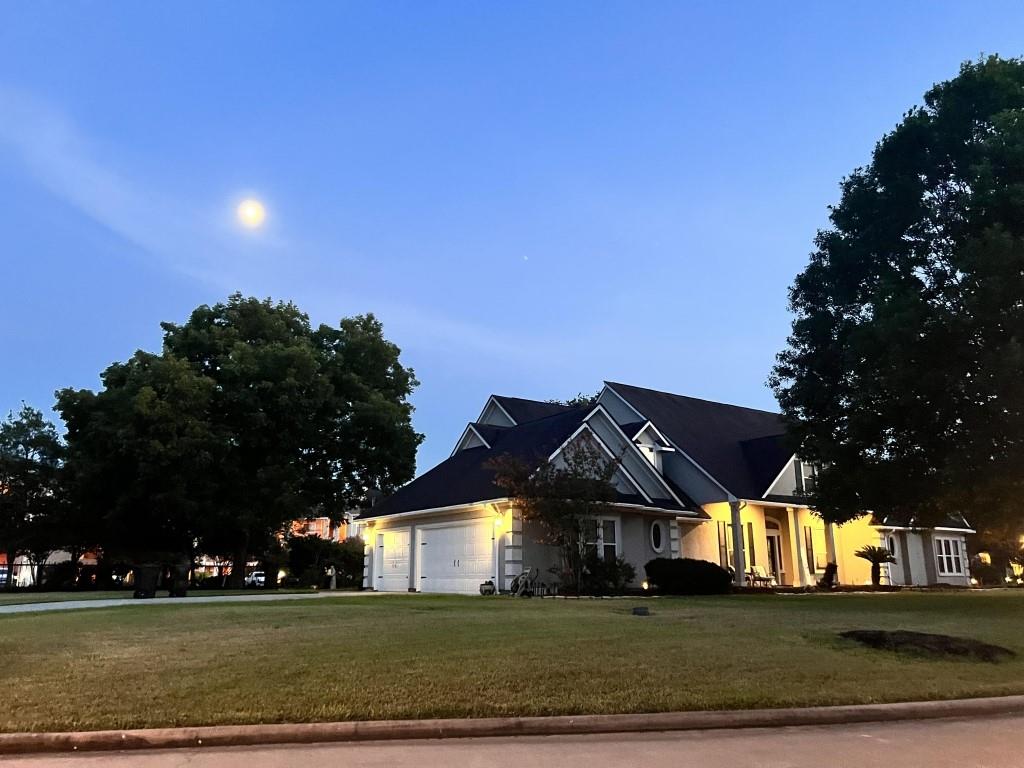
0, 695, 1024, 755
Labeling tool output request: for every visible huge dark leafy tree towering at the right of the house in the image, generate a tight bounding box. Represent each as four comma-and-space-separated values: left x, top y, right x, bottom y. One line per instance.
772, 56, 1024, 523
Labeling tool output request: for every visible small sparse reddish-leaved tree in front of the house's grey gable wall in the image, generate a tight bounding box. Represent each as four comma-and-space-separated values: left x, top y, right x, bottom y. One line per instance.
490, 434, 618, 592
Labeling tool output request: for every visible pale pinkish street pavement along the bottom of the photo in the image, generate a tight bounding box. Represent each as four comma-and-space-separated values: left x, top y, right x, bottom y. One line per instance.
9, 716, 1024, 768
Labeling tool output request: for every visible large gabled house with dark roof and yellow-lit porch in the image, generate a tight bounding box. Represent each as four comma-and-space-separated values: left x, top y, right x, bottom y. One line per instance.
354, 382, 973, 594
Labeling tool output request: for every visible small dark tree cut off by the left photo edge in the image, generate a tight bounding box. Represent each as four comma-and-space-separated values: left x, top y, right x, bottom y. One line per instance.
0, 404, 65, 589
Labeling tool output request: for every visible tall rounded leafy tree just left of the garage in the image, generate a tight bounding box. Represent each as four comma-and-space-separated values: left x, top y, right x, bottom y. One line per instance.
163, 294, 423, 586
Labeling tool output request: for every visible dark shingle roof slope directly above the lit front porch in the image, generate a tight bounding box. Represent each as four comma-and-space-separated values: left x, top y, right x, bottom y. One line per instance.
607, 382, 793, 499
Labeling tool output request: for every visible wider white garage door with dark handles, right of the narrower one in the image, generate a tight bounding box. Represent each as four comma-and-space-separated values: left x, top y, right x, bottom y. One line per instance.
418, 518, 495, 595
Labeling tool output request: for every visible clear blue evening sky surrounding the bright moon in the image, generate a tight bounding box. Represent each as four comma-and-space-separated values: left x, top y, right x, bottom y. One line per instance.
0, 0, 1024, 471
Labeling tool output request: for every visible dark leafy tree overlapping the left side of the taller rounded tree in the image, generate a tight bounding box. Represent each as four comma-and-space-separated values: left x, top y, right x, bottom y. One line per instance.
57, 351, 224, 562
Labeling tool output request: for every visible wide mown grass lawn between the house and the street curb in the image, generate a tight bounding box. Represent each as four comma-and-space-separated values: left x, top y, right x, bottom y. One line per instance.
0, 592, 1024, 731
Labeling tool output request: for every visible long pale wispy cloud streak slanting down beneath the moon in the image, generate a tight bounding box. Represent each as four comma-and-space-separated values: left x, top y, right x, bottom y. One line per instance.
0, 85, 558, 367
